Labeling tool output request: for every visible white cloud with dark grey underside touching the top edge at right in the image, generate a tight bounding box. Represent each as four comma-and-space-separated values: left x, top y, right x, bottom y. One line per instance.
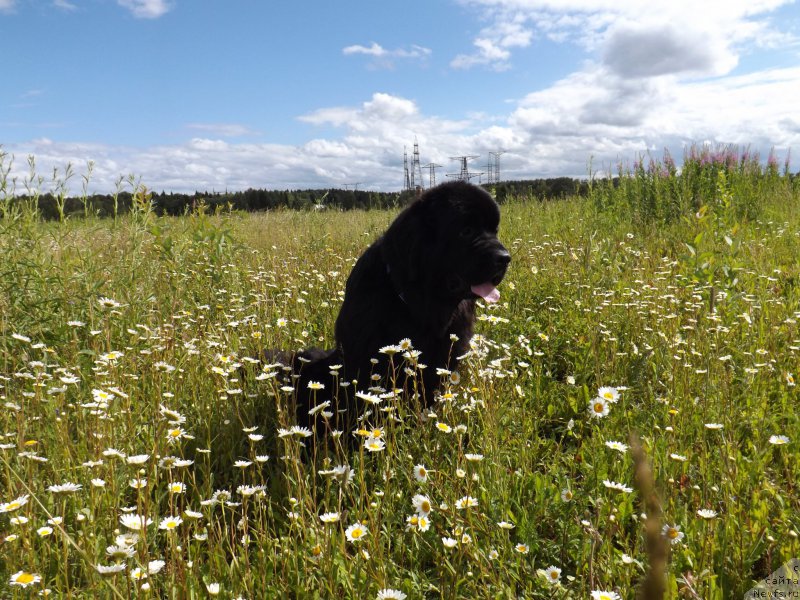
452, 0, 797, 77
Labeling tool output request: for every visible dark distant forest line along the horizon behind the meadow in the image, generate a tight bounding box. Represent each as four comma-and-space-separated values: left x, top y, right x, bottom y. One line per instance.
0, 177, 588, 219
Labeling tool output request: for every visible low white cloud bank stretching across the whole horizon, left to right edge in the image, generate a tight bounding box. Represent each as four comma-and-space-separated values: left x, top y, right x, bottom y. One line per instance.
5, 63, 800, 192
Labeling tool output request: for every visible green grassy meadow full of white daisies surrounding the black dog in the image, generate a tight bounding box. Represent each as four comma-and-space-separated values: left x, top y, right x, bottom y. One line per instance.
0, 149, 800, 599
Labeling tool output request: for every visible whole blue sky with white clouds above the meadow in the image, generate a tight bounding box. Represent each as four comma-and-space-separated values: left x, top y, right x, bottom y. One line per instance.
0, 0, 800, 191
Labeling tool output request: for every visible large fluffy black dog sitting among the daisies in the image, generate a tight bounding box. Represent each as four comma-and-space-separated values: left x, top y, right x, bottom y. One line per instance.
278, 182, 511, 436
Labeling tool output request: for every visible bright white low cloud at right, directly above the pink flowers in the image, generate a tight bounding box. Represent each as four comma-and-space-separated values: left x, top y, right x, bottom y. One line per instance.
509, 64, 800, 174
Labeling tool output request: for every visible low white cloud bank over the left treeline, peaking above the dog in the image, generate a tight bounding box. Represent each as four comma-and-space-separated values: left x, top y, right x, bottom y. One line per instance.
1, 93, 494, 192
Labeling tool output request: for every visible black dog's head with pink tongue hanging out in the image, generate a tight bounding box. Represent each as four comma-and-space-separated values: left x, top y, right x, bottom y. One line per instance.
384, 181, 511, 302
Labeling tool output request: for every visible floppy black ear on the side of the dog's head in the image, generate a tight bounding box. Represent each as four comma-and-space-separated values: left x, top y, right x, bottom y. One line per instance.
381, 196, 434, 289
